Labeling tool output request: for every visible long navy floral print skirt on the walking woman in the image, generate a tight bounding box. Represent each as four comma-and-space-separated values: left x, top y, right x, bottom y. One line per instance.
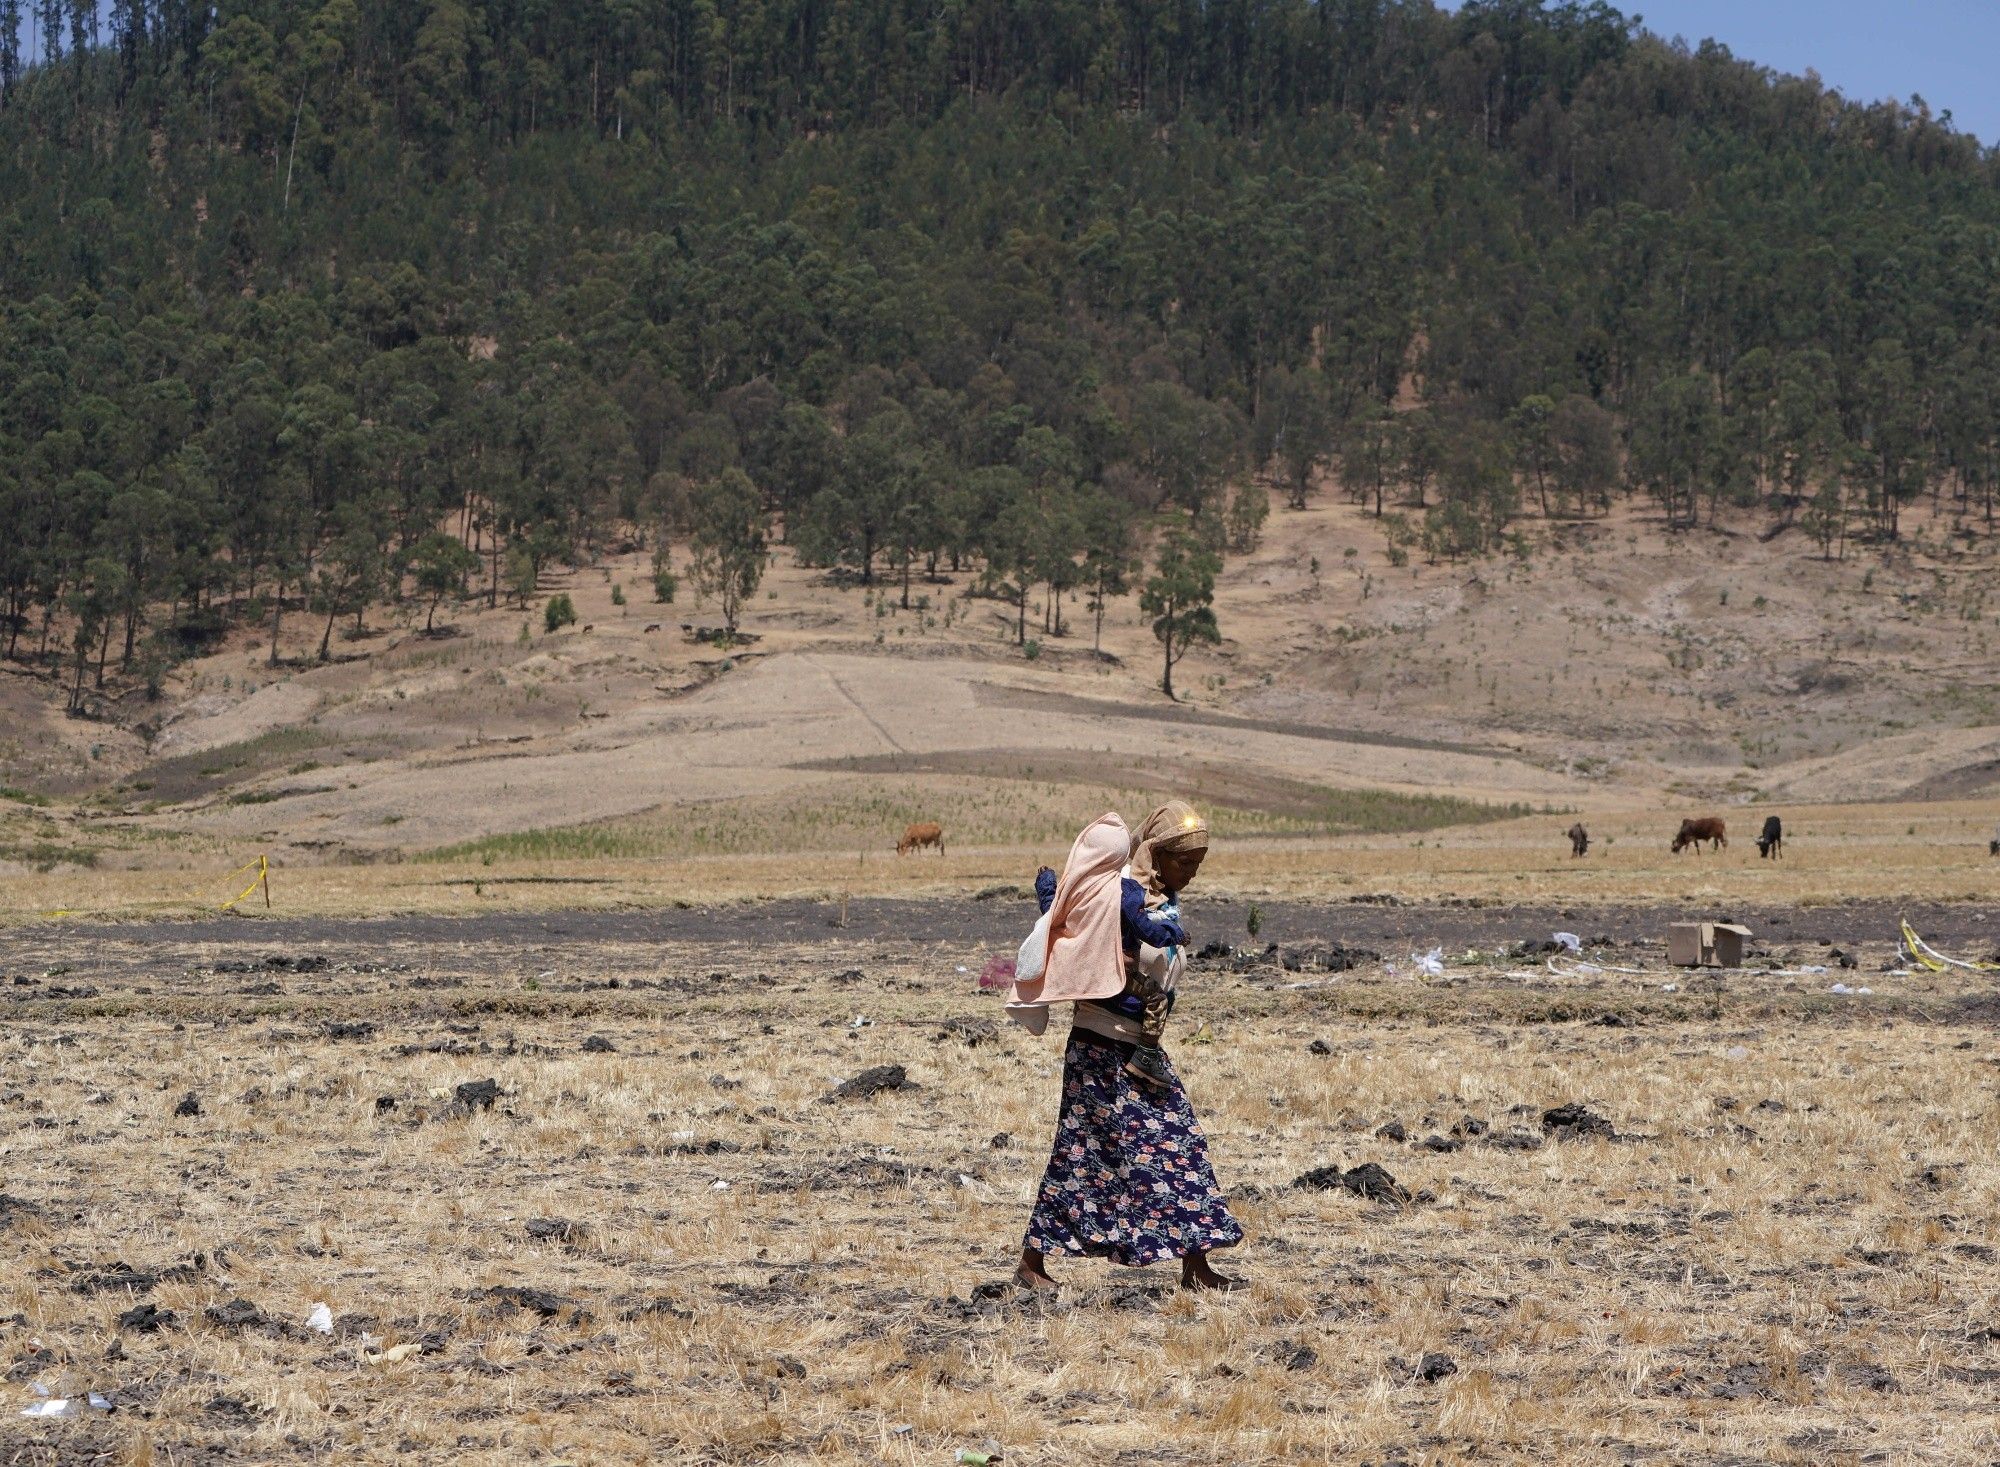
1024, 1031, 1244, 1267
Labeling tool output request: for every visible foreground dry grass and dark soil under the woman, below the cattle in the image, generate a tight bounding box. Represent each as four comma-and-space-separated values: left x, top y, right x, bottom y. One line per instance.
0, 895, 2000, 1467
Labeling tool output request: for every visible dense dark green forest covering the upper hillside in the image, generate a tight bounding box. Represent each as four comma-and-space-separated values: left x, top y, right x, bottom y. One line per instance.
0, 0, 2000, 706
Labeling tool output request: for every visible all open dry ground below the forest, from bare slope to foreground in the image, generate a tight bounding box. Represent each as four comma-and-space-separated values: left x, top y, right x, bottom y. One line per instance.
0, 502, 2000, 1467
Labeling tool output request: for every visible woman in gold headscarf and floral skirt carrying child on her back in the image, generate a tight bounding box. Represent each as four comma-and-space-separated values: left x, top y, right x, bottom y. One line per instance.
1014, 801, 1242, 1289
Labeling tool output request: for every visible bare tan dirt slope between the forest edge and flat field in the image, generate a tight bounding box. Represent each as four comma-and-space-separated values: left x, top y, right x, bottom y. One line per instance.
0, 492, 2000, 871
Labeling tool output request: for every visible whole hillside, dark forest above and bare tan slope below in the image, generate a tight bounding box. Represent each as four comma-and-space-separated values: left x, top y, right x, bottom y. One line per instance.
0, 0, 2000, 863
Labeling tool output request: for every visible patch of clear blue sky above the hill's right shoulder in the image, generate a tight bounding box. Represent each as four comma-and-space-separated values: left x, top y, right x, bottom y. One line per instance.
1472, 0, 2000, 144
